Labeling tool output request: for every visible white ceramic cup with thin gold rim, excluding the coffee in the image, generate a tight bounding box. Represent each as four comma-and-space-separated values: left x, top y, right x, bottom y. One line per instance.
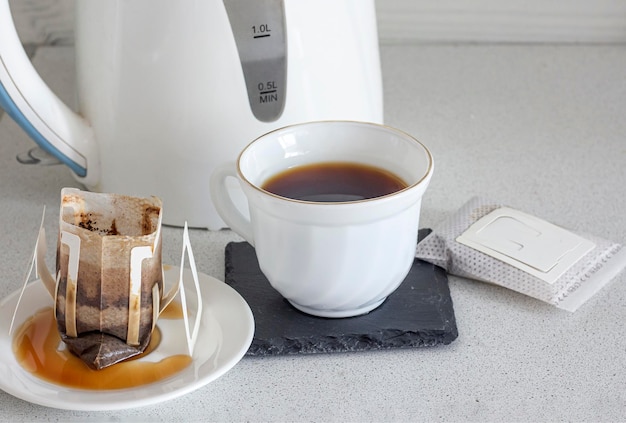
210, 121, 434, 317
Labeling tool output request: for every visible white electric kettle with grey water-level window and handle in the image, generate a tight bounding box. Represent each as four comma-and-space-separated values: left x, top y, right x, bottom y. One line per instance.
0, 0, 383, 229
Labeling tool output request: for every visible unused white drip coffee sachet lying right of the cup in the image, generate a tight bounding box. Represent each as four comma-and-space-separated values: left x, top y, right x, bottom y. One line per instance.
416, 197, 626, 312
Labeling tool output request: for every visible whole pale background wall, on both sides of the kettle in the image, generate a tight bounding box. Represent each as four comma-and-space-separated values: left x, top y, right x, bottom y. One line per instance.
10, 0, 626, 44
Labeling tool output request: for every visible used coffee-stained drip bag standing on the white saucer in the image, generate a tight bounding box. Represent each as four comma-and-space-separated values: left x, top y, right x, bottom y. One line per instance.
55, 188, 163, 369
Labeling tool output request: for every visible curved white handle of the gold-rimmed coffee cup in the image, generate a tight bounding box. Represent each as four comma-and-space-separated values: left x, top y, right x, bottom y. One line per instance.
209, 162, 254, 246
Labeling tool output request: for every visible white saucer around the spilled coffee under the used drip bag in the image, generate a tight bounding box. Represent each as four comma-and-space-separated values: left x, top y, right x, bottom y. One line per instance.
0, 266, 254, 411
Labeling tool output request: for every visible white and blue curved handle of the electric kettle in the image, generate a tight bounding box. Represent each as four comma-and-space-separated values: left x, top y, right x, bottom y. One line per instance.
0, 0, 99, 187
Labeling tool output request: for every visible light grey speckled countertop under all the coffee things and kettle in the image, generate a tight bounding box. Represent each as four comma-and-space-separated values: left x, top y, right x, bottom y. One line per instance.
0, 45, 626, 422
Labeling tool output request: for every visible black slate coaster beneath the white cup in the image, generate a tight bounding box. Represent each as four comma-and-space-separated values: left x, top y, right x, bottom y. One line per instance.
225, 230, 458, 355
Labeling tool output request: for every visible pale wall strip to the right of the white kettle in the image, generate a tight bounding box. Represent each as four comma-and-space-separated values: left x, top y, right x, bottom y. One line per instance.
376, 0, 626, 43
